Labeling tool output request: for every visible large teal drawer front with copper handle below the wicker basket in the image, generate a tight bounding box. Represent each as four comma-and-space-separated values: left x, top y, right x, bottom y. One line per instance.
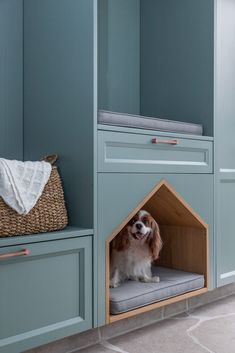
0, 236, 92, 353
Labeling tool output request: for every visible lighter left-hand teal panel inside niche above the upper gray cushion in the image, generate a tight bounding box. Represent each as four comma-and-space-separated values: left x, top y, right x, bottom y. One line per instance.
99, 0, 140, 114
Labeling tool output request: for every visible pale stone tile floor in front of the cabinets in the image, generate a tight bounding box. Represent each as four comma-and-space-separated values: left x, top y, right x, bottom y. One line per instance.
78, 295, 235, 353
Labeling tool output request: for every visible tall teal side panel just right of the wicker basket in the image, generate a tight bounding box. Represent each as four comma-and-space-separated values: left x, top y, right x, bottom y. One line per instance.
24, 0, 94, 228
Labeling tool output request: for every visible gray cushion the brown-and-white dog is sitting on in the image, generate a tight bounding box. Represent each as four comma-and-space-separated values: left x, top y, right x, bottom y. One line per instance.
110, 266, 205, 314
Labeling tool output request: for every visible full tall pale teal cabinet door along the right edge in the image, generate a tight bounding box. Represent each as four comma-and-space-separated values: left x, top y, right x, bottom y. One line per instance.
215, 0, 235, 286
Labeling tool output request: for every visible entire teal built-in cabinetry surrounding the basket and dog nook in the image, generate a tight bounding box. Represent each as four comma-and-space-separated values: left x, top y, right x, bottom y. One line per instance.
0, 0, 235, 346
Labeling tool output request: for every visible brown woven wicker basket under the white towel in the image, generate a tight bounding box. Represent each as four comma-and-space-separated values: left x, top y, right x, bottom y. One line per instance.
0, 156, 68, 237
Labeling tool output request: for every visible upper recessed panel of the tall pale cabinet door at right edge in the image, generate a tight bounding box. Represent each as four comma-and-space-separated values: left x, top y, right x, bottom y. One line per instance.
215, 0, 235, 172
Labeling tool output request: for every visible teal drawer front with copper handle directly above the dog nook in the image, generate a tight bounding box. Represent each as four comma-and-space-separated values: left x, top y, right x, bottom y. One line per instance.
98, 131, 213, 173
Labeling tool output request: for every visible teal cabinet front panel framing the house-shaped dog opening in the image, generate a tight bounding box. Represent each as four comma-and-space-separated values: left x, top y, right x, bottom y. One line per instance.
95, 173, 215, 326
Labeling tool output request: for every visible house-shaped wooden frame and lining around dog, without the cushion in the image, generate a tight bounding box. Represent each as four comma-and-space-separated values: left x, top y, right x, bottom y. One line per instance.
106, 180, 209, 324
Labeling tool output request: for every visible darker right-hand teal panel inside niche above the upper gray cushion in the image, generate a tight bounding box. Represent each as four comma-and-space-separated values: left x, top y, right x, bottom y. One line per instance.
141, 0, 214, 136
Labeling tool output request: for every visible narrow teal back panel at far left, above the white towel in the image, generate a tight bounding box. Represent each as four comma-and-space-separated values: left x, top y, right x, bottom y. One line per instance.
0, 0, 23, 159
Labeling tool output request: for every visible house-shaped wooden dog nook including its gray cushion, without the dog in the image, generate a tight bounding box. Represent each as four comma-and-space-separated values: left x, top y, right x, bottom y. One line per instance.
106, 180, 208, 323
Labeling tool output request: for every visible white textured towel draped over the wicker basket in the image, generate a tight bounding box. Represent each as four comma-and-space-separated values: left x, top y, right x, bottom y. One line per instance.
0, 158, 52, 215
